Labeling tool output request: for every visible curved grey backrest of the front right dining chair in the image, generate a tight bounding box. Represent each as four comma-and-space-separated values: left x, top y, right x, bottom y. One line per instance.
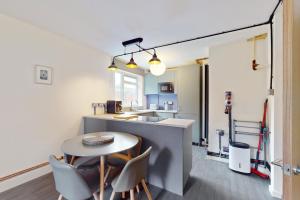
114, 147, 152, 192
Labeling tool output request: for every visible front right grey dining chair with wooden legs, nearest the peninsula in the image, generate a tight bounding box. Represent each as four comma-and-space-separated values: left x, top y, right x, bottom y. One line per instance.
110, 147, 152, 200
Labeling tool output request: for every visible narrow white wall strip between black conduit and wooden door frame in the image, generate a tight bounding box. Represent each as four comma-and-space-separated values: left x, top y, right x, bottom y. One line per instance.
269, 5, 283, 198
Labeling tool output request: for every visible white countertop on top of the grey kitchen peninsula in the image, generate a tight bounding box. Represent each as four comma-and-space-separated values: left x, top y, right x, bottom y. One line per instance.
84, 114, 195, 128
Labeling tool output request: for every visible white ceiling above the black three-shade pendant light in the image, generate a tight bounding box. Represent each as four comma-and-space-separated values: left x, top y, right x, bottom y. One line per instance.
0, 0, 277, 67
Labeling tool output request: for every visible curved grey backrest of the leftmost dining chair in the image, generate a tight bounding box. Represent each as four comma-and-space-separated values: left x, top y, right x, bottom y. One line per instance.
49, 155, 92, 200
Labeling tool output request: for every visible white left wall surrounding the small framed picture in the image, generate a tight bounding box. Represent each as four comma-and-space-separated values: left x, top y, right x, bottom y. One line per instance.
0, 15, 113, 192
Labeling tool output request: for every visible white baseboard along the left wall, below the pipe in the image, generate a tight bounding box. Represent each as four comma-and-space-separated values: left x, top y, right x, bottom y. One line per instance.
0, 165, 51, 193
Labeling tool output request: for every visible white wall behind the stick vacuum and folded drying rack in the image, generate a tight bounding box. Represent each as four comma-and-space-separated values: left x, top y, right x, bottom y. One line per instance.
208, 39, 269, 158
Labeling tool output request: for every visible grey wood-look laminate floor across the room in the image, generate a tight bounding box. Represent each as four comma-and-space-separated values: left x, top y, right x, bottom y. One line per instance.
0, 147, 275, 200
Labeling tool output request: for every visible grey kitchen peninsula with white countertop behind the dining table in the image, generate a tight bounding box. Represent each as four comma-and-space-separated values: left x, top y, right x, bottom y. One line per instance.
84, 114, 194, 195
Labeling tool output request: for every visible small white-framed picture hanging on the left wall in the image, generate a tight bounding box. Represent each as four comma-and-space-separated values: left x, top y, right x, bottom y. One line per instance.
35, 65, 53, 85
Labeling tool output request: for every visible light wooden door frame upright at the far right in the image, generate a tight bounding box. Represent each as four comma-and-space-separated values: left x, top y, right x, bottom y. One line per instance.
283, 0, 300, 200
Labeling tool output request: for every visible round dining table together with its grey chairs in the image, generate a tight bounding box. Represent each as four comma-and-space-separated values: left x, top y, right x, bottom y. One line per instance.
49, 131, 152, 200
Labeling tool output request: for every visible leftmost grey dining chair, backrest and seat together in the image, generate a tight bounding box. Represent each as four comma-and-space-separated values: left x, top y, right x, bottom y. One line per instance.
49, 155, 99, 200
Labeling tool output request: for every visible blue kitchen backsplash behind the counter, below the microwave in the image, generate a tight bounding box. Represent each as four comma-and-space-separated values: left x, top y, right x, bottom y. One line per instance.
146, 94, 177, 110
